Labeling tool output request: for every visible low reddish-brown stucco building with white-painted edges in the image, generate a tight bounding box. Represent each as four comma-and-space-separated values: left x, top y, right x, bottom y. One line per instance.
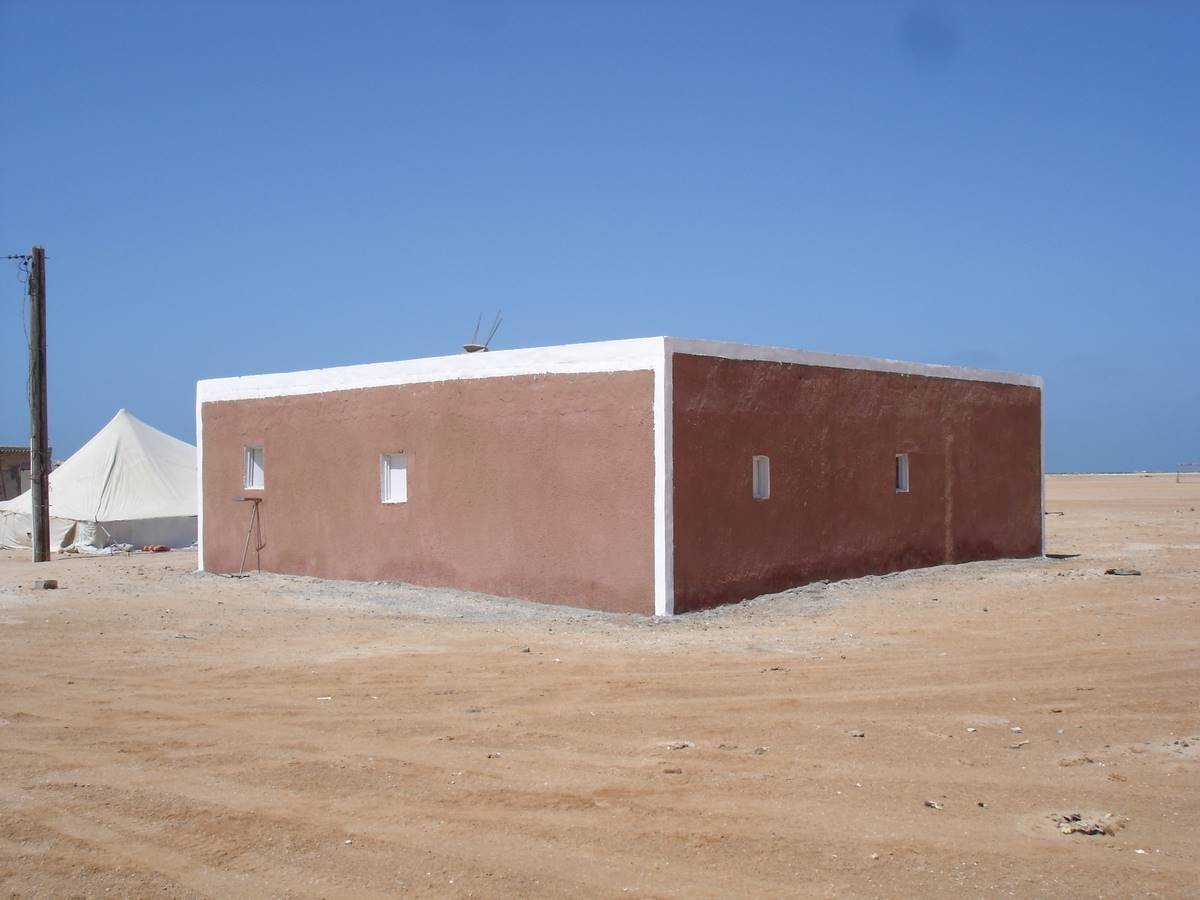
196, 337, 1043, 616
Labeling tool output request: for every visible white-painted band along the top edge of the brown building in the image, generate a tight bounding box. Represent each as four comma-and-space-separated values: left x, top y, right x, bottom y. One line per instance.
196, 337, 1043, 403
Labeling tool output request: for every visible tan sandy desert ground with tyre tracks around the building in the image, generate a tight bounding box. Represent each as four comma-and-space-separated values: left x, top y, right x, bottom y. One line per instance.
0, 475, 1200, 898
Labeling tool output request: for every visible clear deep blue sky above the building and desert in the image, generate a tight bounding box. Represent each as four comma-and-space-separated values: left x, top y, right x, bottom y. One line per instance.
0, 0, 1200, 470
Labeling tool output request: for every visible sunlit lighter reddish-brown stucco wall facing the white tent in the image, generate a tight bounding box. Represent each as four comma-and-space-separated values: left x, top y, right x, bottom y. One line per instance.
202, 372, 654, 613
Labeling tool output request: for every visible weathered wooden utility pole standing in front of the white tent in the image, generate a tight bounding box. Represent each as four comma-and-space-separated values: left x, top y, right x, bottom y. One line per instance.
29, 247, 50, 563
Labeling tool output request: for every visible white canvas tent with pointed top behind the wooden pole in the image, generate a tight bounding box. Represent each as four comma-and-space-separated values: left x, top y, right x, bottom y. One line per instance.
0, 409, 197, 552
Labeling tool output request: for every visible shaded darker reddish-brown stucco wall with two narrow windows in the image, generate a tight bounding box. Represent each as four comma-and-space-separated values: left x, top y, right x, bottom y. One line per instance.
672, 354, 1042, 612
